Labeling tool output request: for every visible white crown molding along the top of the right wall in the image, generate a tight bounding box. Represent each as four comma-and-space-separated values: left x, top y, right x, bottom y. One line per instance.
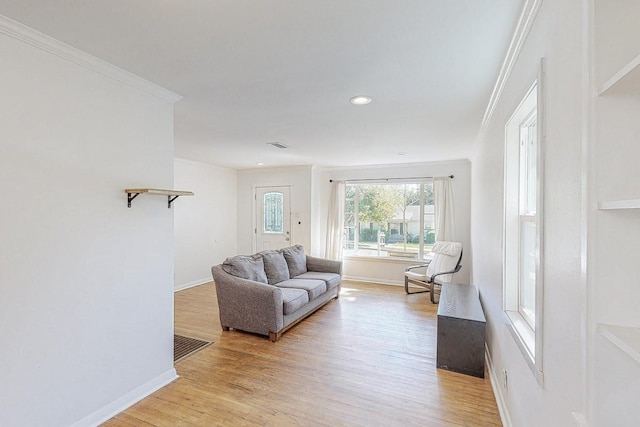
476, 0, 543, 141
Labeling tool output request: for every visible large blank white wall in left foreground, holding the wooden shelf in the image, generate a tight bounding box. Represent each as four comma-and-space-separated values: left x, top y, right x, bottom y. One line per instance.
0, 16, 175, 426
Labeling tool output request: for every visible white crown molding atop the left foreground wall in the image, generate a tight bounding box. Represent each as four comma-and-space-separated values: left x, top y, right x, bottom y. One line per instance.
0, 15, 182, 103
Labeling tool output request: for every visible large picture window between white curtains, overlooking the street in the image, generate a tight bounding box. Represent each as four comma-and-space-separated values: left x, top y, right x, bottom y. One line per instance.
344, 181, 434, 259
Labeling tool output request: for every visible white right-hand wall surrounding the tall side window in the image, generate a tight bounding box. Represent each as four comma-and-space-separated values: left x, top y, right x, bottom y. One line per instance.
471, 0, 588, 427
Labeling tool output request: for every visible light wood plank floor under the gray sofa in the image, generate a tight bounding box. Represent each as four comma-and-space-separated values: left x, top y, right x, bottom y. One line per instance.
104, 282, 501, 427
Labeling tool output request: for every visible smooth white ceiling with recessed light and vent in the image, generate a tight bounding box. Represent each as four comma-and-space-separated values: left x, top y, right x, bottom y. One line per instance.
0, 0, 524, 168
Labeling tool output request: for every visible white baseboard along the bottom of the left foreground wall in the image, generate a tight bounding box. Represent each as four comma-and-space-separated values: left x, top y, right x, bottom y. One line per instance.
71, 368, 178, 427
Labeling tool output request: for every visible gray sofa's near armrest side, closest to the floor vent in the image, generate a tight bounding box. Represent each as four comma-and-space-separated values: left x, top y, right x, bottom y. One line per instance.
211, 265, 284, 335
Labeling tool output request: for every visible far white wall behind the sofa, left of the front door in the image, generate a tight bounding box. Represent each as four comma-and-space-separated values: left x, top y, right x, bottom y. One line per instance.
174, 159, 238, 289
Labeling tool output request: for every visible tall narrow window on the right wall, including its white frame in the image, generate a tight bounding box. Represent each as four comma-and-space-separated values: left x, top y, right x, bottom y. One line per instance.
504, 76, 543, 382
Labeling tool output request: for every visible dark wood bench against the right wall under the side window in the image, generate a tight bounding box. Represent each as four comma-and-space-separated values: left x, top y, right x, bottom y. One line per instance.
436, 283, 486, 378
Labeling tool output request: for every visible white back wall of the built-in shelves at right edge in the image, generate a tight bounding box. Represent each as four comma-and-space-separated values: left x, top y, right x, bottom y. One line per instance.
588, 0, 640, 427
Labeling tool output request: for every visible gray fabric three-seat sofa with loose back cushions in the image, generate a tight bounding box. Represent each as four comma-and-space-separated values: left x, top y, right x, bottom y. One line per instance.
211, 245, 342, 342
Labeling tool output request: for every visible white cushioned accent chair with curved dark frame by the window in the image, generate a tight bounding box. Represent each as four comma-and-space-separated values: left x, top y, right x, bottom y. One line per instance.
404, 241, 462, 304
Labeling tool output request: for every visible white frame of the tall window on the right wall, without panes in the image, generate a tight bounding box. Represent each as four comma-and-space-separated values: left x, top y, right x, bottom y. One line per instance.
503, 60, 545, 386
